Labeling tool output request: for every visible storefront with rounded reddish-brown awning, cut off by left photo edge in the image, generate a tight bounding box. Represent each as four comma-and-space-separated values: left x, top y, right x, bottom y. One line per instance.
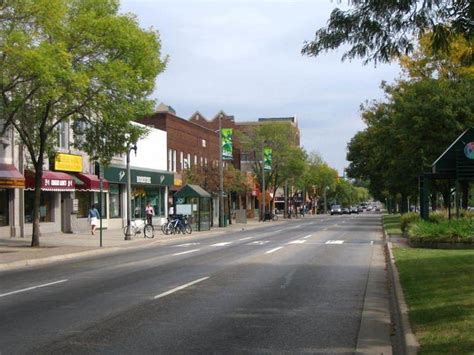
0, 164, 25, 236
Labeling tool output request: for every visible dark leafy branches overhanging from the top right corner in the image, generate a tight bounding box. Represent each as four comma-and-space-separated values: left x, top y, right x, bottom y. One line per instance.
302, 0, 474, 63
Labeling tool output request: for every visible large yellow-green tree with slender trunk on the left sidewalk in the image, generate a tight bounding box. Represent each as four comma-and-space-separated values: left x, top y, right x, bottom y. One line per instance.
0, 0, 165, 246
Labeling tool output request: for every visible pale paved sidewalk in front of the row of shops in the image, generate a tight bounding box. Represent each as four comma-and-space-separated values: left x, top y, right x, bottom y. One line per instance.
0, 219, 272, 272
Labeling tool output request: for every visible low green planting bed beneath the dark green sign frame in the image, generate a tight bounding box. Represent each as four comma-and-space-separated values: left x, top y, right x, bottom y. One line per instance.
408, 219, 474, 243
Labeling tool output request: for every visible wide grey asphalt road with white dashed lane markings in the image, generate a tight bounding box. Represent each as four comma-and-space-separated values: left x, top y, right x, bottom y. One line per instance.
0, 214, 392, 354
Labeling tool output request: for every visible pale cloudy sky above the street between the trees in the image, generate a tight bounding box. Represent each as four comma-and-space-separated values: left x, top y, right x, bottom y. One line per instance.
121, 0, 400, 175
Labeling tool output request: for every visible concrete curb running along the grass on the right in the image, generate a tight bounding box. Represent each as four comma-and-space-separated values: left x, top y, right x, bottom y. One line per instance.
383, 229, 420, 355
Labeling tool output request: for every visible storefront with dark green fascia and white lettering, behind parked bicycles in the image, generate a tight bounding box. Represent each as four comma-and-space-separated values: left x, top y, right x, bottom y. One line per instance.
104, 166, 174, 228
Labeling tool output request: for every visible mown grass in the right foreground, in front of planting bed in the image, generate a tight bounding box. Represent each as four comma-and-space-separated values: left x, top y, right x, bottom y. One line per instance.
394, 248, 474, 354
